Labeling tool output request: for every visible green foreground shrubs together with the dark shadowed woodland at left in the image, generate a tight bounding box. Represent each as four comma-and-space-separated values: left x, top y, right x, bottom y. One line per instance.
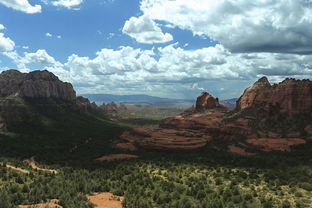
0, 103, 312, 208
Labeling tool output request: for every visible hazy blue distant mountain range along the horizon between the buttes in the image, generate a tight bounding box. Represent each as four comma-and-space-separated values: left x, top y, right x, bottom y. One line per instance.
81, 94, 195, 104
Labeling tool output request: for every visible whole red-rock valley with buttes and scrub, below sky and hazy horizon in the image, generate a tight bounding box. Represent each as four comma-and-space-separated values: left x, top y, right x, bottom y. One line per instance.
0, 70, 312, 208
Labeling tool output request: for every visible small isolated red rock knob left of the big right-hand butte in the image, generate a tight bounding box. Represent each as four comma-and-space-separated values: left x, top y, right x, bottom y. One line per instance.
195, 92, 220, 111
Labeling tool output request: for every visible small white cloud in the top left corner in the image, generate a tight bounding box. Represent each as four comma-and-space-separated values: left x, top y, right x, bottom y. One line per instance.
0, 0, 41, 14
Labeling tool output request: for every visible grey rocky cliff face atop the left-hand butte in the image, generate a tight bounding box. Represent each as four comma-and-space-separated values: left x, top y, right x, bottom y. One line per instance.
0, 70, 76, 101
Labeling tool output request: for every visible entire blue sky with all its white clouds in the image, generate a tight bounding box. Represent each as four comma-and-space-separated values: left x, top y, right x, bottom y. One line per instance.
0, 0, 312, 99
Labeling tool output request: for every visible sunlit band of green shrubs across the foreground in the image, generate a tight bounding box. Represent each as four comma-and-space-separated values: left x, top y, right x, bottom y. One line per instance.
0, 151, 312, 208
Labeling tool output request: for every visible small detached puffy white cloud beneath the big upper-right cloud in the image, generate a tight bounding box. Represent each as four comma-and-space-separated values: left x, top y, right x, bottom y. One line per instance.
122, 15, 173, 44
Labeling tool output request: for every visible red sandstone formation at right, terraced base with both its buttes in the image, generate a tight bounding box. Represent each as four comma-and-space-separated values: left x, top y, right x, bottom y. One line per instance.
116, 77, 312, 155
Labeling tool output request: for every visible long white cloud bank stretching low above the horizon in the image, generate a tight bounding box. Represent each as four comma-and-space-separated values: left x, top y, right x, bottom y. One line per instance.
5, 44, 312, 98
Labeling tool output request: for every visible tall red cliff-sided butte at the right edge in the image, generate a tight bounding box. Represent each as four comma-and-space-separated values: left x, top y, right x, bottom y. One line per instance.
237, 77, 312, 115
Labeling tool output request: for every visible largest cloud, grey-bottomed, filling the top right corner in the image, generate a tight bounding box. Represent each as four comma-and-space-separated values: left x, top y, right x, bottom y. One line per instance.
141, 0, 312, 54
